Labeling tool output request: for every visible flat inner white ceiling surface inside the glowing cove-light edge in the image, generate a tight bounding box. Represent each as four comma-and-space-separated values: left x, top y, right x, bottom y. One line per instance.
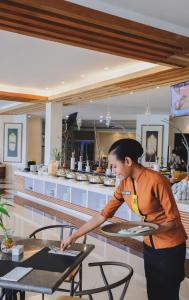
0, 30, 132, 89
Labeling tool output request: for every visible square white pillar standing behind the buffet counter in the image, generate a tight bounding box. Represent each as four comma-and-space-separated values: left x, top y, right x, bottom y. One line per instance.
45, 102, 62, 165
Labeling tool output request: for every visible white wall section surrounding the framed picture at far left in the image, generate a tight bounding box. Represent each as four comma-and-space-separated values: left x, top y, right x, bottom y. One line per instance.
0, 115, 27, 180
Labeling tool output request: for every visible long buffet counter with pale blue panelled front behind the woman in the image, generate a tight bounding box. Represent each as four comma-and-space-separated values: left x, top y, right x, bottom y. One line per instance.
15, 172, 189, 247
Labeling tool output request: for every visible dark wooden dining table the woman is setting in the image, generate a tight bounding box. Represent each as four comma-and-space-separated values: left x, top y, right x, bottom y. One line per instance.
0, 238, 94, 294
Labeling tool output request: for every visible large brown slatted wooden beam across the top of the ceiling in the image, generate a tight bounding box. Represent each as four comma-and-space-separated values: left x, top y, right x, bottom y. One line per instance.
0, 0, 189, 67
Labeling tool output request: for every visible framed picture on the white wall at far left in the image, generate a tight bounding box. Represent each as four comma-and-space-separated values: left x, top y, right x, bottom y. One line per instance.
3, 123, 22, 163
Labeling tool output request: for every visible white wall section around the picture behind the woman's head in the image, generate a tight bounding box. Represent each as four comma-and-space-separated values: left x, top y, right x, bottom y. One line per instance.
136, 114, 169, 166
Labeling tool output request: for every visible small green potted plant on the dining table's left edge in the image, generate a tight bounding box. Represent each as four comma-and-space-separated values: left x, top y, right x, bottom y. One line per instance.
0, 197, 14, 252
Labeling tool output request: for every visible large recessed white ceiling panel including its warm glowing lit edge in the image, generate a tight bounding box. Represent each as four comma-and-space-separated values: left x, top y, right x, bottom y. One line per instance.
0, 30, 155, 96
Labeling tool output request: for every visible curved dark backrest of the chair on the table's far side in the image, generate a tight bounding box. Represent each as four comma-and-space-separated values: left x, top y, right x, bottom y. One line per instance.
29, 224, 87, 244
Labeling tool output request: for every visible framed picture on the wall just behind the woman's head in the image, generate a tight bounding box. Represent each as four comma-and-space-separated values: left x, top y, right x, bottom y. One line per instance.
141, 125, 164, 166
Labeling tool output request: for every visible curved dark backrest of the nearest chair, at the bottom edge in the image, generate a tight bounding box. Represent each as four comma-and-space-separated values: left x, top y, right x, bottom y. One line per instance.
75, 261, 133, 300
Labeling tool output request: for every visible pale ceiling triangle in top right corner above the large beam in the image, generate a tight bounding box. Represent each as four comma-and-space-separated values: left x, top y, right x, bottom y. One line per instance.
67, 0, 189, 36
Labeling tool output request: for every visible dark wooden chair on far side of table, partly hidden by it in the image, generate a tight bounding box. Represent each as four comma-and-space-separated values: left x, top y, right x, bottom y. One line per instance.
29, 225, 87, 296
